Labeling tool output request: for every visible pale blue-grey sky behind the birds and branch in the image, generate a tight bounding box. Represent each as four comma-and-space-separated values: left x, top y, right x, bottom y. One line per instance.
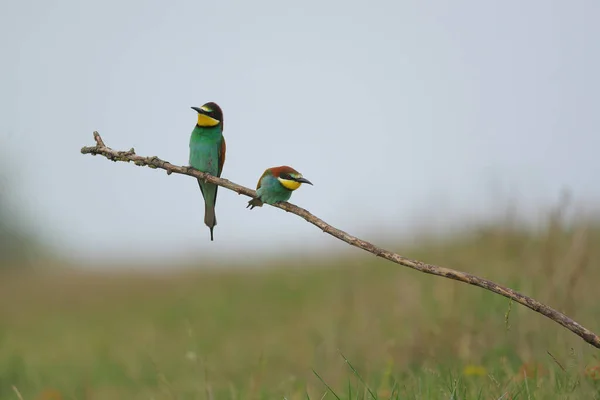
0, 0, 600, 259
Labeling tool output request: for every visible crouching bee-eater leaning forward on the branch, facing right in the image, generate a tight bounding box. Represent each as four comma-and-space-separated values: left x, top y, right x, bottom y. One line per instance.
246, 165, 312, 210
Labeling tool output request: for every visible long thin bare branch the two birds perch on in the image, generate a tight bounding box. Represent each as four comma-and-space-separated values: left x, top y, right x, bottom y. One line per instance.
81, 132, 600, 349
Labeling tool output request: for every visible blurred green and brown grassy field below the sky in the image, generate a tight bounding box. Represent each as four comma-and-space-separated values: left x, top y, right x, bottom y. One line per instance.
0, 219, 600, 400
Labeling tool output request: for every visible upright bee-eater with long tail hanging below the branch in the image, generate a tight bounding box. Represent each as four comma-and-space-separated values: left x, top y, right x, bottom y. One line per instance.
190, 102, 226, 240
